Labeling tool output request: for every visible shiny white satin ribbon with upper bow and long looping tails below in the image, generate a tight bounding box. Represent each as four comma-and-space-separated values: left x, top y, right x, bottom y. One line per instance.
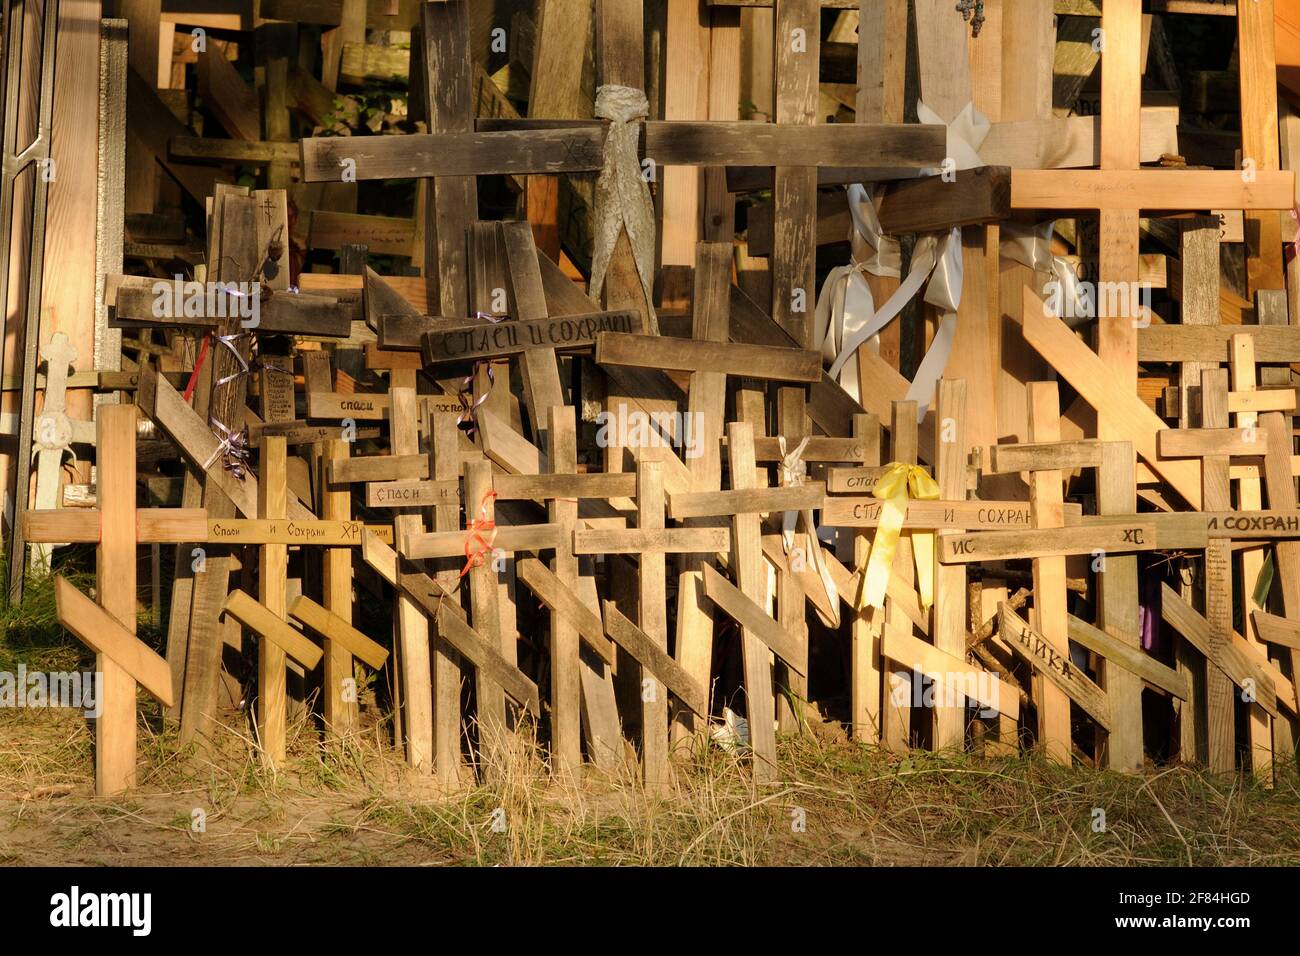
815, 101, 991, 421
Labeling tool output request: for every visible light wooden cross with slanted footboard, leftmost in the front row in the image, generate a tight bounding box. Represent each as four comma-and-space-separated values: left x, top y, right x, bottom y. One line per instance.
23, 405, 192, 795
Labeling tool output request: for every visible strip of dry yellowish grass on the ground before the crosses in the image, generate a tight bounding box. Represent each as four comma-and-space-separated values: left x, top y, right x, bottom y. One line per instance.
0, 710, 1300, 866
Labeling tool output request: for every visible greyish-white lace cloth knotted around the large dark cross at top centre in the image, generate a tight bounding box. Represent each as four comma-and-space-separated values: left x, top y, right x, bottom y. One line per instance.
590, 86, 655, 332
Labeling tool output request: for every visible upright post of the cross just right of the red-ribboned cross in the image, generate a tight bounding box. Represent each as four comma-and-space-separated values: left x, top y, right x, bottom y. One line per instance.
547, 406, 582, 778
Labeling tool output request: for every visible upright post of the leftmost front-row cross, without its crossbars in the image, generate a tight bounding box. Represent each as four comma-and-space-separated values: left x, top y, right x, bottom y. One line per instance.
95, 405, 135, 796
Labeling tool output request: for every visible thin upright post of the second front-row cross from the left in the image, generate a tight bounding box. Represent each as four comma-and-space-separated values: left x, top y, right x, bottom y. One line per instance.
257, 436, 289, 765
